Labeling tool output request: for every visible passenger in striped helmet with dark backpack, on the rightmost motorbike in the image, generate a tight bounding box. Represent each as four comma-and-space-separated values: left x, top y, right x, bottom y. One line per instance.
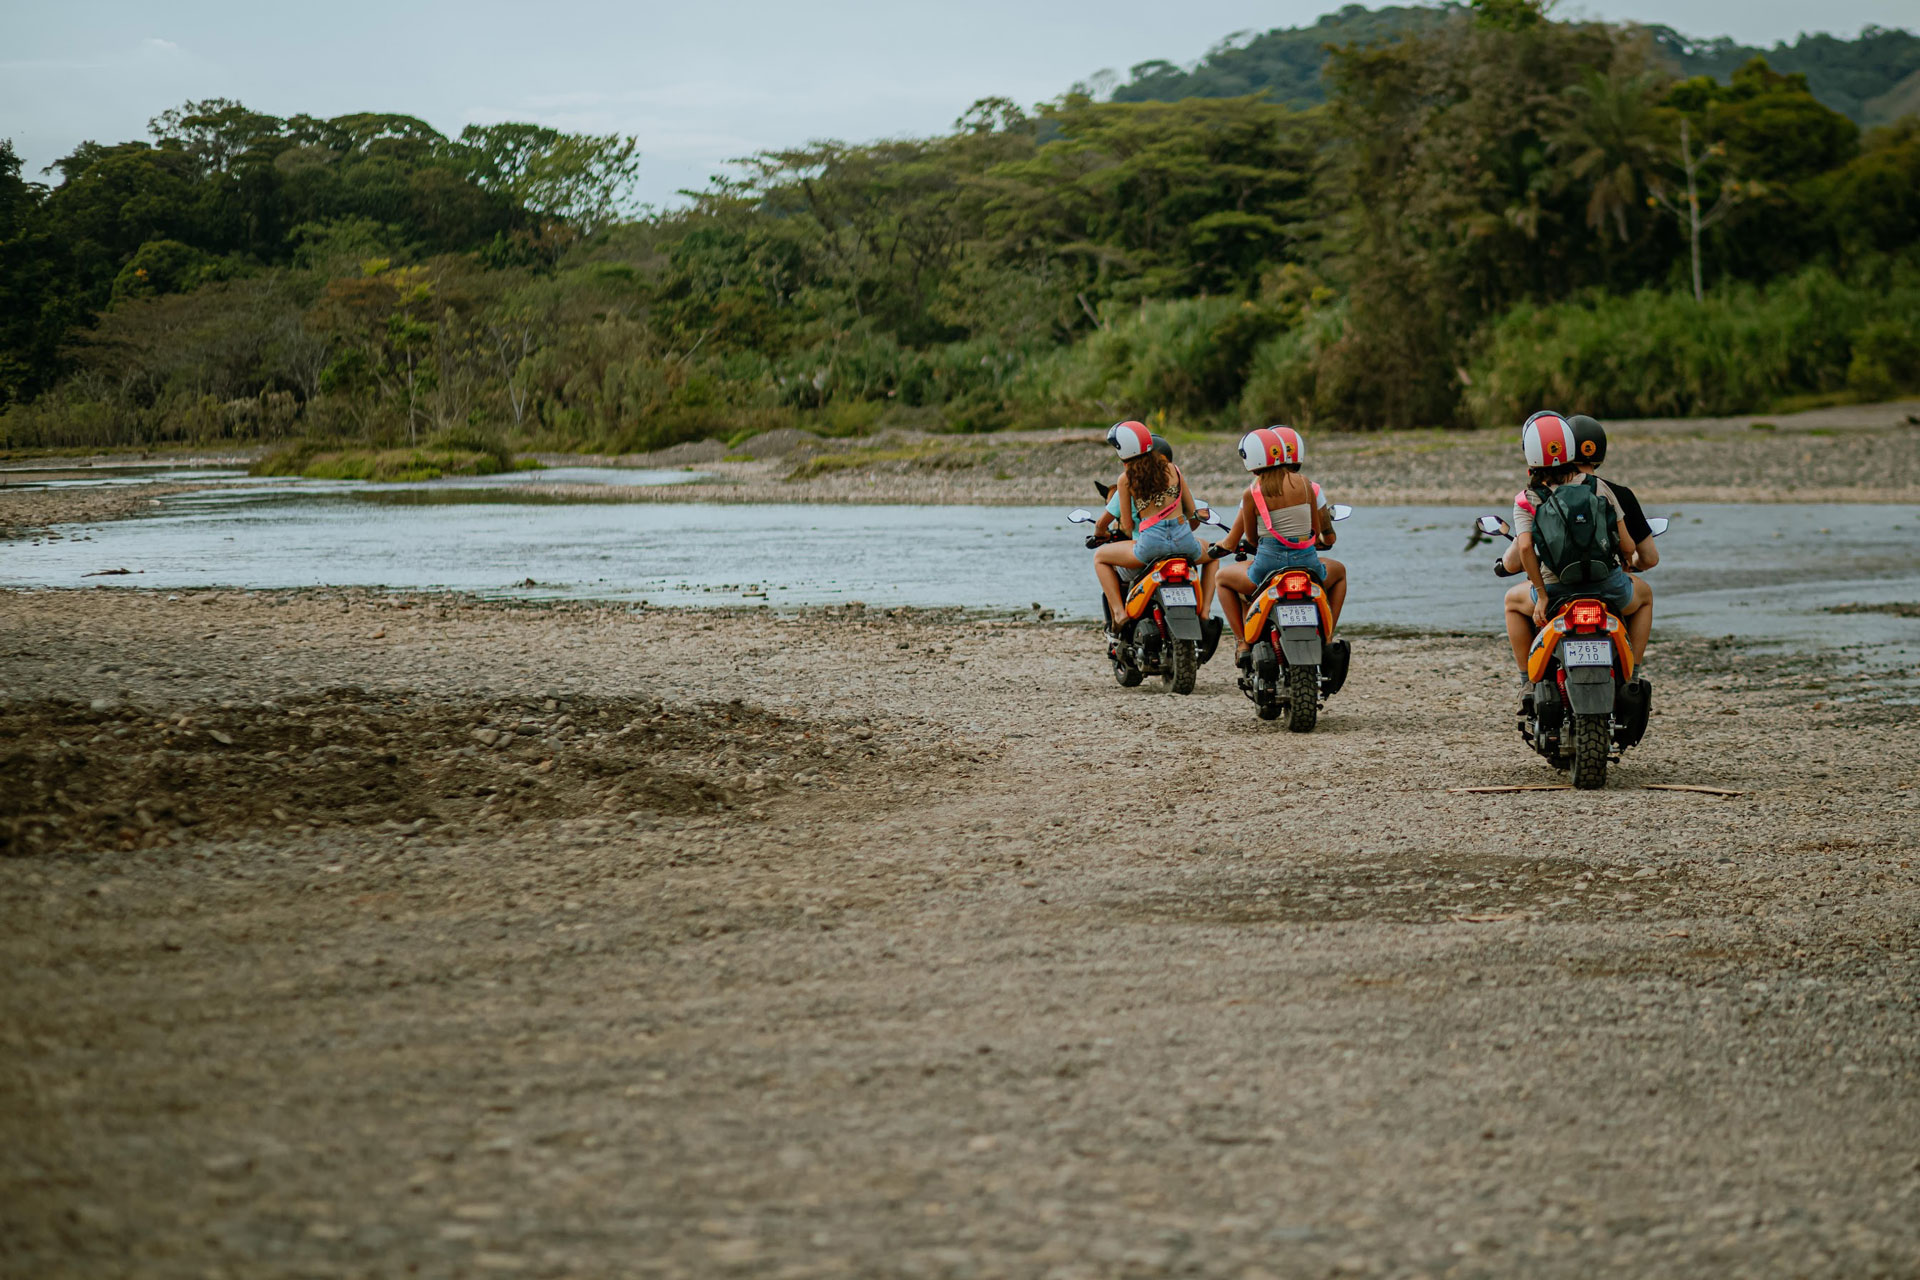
1507, 411, 1651, 676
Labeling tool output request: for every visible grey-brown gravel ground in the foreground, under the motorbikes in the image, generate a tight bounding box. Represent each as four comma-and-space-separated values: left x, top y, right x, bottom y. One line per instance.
0, 591, 1920, 1280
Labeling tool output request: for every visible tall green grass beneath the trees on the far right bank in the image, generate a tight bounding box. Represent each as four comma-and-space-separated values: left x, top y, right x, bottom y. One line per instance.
1465, 259, 1920, 422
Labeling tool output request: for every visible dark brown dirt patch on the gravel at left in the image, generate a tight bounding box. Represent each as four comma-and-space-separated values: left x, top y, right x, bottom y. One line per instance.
0, 689, 877, 856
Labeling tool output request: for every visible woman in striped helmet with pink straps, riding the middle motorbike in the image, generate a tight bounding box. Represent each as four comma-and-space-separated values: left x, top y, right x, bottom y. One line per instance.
1210, 426, 1346, 666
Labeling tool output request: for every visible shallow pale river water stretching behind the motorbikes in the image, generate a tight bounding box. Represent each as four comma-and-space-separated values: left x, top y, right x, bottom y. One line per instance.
0, 468, 1920, 656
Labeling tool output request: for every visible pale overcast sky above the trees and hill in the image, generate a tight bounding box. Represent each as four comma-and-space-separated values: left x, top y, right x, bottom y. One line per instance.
0, 0, 1914, 203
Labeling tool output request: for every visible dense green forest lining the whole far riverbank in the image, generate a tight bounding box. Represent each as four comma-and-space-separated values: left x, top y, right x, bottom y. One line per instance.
0, 0, 1920, 451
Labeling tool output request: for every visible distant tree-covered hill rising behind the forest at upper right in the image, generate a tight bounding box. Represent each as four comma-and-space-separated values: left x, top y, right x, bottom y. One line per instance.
1114, 4, 1920, 125
